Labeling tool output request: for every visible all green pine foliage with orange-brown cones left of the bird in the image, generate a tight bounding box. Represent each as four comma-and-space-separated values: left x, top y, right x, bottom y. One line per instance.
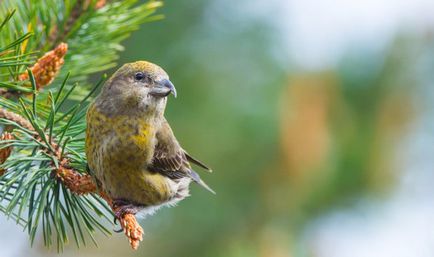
0, 0, 162, 251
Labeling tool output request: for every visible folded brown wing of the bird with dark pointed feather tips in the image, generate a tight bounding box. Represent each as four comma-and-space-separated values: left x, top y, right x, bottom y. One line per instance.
148, 120, 214, 193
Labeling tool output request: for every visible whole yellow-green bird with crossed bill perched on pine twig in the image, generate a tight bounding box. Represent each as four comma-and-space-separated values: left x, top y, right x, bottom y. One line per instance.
85, 61, 215, 248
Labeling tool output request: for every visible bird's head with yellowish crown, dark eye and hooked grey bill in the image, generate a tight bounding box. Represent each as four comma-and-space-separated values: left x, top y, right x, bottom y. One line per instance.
99, 61, 176, 112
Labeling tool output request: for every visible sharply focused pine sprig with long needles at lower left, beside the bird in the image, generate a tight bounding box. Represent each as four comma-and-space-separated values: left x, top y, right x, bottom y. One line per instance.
0, 70, 111, 250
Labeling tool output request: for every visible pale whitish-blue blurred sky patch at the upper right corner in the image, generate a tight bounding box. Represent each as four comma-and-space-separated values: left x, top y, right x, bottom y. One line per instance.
280, 0, 434, 69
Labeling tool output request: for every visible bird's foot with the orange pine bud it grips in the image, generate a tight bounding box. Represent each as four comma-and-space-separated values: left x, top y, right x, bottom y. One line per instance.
113, 201, 144, 250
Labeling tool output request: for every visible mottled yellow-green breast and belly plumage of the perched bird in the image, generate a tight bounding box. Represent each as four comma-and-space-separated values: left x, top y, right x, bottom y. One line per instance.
86, 104, 170, 205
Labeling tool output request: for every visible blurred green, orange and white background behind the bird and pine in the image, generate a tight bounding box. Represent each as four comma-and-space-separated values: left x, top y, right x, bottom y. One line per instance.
0, 0, 434, 257
